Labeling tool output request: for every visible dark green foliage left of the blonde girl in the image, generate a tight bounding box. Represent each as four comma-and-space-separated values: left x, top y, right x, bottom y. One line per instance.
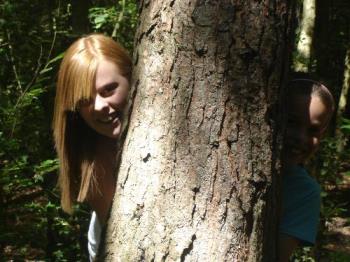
0, 1, 77, 260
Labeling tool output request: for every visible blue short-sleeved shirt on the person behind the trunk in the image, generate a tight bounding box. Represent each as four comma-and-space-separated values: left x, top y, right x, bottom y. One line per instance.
280, 165, 321, 245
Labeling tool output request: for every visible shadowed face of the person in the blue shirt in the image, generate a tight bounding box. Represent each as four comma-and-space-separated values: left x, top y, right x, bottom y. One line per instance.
283, 94, 330, 164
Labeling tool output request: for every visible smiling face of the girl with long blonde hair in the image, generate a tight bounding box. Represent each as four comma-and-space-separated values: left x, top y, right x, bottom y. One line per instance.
79, 60, 129, 138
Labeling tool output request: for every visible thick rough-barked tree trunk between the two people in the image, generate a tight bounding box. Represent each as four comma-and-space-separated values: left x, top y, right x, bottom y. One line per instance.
101, 0, 289, 261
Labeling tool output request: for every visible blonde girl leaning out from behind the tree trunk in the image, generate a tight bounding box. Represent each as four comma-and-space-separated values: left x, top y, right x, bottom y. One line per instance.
53, 34, 132, 260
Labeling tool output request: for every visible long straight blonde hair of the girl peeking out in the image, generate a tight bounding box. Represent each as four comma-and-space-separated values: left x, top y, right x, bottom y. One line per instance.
53, 34, 132, 213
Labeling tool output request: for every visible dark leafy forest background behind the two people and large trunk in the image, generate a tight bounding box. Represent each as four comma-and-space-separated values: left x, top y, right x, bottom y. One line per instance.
0, 0, 350, 261
